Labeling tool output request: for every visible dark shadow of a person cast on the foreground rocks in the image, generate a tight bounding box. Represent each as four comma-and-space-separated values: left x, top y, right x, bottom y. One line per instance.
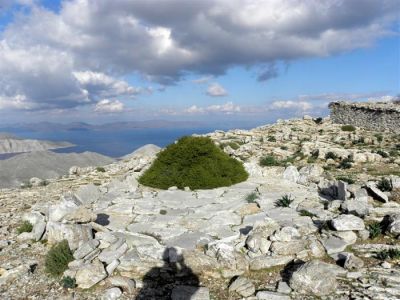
135, 247, 200, 300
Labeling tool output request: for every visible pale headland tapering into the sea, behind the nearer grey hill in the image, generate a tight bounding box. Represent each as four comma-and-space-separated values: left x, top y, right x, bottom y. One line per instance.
0, 133, 74, 154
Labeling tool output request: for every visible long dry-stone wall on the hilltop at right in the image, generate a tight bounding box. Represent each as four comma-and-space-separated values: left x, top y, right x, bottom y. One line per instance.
329, 102, 400, 133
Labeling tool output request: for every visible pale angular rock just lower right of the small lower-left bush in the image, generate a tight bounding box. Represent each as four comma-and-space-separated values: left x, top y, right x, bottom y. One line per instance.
75, 260, 107, 289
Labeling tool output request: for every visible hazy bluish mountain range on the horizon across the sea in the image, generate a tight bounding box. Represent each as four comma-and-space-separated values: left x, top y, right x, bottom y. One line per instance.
0, 120, 204, 132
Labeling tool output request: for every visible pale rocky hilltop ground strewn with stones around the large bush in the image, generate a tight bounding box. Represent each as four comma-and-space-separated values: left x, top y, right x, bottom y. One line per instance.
0, 117, 400, 300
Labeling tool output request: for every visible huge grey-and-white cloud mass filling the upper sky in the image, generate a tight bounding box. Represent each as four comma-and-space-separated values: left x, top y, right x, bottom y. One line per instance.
0, 0, 398, 109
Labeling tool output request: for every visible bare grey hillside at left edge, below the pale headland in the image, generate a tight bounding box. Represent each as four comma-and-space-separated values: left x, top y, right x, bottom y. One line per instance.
0, 151, 115, 188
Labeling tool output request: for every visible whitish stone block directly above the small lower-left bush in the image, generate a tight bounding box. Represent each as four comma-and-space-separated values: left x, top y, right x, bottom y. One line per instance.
46, 222, 93, 250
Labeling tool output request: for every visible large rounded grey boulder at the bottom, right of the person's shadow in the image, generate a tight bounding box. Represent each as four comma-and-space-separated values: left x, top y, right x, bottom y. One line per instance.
289, 260, 338, 297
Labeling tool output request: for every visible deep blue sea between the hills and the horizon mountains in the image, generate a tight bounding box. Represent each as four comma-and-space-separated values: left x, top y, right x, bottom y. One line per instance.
0, 127, 244, 159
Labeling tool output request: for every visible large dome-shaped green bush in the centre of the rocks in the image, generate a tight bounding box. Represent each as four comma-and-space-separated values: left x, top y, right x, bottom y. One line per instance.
139, 137, 249, 190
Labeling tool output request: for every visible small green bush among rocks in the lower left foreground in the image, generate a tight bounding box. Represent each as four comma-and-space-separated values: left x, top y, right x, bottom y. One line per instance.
45, 240, 74, 276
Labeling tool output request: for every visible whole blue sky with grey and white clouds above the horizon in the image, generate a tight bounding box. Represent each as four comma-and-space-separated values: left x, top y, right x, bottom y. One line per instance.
0, 0, 400, 124
